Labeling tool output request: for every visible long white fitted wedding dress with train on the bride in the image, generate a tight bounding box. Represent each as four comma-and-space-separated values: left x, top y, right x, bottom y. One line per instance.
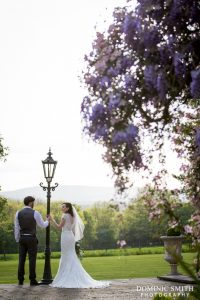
50, 213, 109, 288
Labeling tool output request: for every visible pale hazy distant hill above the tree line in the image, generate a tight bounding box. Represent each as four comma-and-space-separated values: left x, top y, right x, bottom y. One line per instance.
0, 185, 115, 207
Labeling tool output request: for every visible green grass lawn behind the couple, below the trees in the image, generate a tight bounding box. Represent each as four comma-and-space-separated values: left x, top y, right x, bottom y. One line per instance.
0, 253, 195, 283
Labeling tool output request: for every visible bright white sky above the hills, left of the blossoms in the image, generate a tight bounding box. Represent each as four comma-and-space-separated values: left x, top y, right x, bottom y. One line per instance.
0, 0, 180, 191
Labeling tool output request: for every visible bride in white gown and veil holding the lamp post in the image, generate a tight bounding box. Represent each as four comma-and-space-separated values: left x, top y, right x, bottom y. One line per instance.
50, 202, 109, 288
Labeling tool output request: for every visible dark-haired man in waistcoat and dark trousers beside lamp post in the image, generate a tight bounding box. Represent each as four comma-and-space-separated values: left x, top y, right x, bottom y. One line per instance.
15, 196, 49, 286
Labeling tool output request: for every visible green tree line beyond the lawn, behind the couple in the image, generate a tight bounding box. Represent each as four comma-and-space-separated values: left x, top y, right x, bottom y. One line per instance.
0, 195, 193, 254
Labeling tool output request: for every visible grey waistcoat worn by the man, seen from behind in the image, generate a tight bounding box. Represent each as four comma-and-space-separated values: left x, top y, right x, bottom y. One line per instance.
18, 207, 36, 235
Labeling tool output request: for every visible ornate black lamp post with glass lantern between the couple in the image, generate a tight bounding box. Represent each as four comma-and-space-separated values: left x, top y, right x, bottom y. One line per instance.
40, 148, 58, 284
